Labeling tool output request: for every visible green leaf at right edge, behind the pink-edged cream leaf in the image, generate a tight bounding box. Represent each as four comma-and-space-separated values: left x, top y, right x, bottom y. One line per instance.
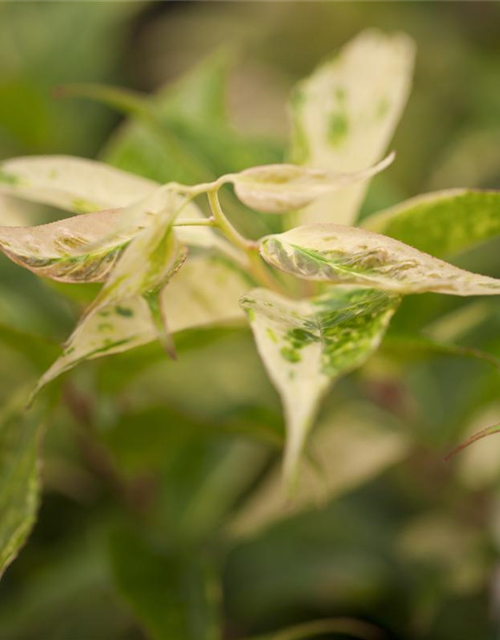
362, 189, 500, 258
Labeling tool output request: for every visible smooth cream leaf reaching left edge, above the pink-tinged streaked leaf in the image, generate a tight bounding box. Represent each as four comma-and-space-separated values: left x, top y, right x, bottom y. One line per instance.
0, 156, 158, 213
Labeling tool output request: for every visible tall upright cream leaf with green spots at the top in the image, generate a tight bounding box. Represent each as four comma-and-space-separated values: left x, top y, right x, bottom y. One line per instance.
290, 30, 414, 229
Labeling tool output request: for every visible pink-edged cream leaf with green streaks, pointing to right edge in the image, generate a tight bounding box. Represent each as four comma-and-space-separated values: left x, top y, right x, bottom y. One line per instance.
261, 224, 500, 296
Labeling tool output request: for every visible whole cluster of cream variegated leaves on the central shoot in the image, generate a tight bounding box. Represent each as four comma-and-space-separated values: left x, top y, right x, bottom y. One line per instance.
0, 31, 500, 490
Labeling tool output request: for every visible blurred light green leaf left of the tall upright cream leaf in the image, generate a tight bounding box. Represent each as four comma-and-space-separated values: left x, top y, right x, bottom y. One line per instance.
94, 51, 282, 184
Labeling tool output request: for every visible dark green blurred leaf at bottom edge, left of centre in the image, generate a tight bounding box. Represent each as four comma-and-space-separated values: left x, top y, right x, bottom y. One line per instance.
110, 531, 220, 640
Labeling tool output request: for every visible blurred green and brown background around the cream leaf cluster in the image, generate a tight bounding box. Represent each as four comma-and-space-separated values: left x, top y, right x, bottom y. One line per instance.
0, 0, 500, 640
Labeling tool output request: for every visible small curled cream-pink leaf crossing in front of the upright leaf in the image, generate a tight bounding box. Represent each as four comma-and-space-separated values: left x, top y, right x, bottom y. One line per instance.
231, 153, 394, 213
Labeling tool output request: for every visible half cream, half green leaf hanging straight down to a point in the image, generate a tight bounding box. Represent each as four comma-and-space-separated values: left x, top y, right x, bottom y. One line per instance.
241, 289, 399, 478
